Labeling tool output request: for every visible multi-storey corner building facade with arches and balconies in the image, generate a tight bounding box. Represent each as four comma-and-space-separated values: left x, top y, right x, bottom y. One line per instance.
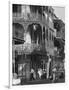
12, 4, 56, 80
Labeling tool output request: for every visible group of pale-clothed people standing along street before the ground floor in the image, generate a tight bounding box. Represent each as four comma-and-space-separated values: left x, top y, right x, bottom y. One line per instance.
30, 68, 56, 81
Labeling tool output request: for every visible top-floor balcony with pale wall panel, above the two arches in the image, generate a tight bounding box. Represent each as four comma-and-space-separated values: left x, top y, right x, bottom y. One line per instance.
13, 4, 42, 21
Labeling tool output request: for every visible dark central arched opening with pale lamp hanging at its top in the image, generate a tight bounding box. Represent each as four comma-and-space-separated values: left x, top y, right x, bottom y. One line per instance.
27, 23, 42, 44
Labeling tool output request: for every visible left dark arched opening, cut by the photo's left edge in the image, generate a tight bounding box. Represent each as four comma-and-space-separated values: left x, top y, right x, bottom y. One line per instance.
13, 23, 24, 44
